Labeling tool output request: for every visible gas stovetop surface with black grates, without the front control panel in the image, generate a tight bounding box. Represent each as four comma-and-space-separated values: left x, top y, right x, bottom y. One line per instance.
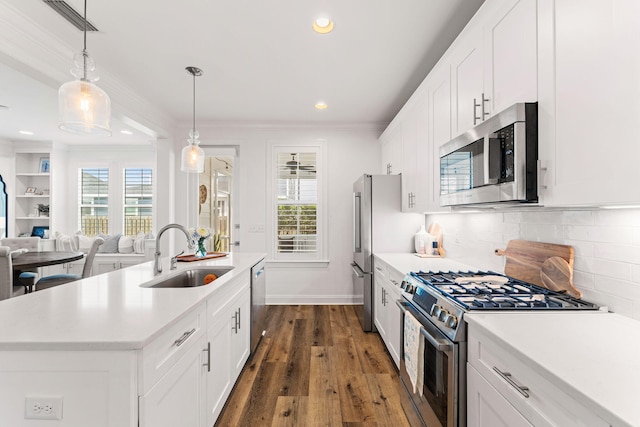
411, 271, 598, 311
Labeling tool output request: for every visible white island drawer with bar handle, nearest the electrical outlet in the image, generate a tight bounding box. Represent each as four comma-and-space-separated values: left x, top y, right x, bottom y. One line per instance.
138, 304, 205, 395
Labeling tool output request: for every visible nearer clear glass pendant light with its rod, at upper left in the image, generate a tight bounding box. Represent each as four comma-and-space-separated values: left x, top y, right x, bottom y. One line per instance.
58, 0, 111, 136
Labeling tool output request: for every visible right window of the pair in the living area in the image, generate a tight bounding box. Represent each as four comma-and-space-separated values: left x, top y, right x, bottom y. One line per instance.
123, 168, 153, 236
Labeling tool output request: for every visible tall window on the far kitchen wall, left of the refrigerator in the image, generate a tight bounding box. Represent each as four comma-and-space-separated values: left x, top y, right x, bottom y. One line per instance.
273, 146, 324, 260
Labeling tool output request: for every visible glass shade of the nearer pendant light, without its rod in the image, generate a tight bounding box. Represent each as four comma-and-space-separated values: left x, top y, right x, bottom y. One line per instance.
58, 80, 111, 136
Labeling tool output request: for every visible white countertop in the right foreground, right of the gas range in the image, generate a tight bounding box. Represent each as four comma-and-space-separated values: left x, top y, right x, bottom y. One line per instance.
465, 312, 640, 427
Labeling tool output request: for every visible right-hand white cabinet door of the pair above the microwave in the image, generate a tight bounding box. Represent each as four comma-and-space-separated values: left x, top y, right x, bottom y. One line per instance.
484, 0, 538, 113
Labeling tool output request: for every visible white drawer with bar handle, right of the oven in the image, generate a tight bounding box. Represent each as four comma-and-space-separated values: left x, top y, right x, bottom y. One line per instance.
468, 325, 609, 427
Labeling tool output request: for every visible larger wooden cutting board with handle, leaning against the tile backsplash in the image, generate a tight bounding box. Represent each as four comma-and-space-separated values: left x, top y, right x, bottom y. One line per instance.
495, 240, 574, 287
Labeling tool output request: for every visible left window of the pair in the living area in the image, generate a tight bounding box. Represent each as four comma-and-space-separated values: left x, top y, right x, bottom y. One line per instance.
78, 168, 109, 236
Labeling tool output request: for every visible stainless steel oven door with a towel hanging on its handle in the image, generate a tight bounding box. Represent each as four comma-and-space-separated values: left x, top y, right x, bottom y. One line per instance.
397, 301, 467, 427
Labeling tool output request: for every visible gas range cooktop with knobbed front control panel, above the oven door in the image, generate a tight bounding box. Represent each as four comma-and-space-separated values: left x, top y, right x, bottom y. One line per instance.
401, 271, 599, 342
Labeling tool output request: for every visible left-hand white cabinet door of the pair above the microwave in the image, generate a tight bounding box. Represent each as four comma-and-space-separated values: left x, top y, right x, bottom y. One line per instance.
451, 22, 488, 137
